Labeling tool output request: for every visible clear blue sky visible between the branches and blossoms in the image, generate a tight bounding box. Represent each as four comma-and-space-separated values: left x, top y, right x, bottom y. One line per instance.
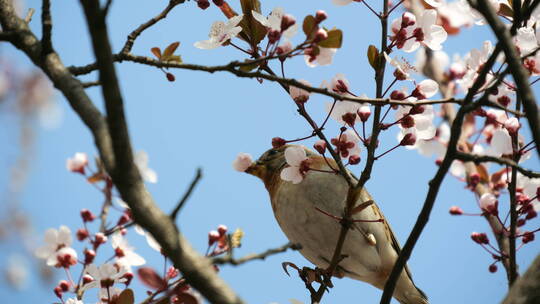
0, 0, 540, 304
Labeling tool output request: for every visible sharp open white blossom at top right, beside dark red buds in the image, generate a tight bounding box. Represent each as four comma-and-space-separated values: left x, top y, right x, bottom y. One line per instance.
403, 10, 448, 53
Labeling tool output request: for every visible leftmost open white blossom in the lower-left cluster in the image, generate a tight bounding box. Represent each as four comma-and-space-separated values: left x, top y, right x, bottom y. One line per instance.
35, 226, 77, 266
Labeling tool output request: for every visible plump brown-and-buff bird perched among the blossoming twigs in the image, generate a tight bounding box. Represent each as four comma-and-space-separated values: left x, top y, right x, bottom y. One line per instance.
245, 144, 428, 304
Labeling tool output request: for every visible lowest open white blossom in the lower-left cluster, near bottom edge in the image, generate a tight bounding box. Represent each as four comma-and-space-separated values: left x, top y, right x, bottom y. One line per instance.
81, 263, 127, 291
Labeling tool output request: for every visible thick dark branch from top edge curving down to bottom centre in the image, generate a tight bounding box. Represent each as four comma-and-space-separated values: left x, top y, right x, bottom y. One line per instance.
76, 0, 242, 303
